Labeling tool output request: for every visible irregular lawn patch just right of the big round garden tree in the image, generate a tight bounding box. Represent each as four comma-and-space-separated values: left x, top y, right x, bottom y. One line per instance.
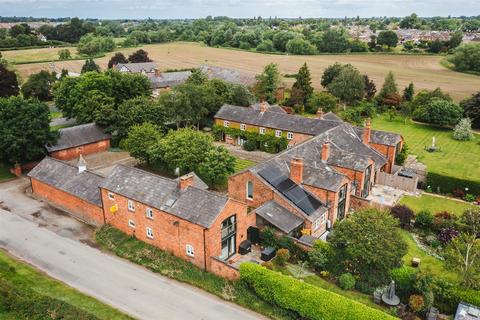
400, 230, 458, 282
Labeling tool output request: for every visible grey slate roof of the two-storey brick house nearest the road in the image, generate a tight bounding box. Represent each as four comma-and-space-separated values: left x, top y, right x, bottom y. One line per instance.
100, 165, 228, 228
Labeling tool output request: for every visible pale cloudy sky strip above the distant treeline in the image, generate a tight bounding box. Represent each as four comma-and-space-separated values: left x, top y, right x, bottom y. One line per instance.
0, 0, 480, 19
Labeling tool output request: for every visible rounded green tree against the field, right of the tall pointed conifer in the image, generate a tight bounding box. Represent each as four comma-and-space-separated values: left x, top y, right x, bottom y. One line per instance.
327, 65, 365, 108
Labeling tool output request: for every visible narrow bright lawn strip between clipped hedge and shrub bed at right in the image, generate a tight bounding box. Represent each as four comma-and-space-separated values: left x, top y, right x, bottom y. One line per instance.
399, 194, 474, 215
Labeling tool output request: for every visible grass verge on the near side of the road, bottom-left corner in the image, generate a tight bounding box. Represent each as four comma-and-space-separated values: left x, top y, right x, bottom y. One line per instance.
0, 250, 132, 320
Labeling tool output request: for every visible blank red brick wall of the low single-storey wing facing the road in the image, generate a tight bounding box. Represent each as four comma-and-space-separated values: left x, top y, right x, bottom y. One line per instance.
30, 178, 104, 226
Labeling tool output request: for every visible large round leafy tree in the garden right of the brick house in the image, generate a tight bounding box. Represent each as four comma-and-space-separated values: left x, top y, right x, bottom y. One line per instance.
329, 209, 407, 287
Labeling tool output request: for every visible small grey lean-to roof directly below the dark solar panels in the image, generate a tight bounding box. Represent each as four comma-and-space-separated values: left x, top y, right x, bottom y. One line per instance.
255, 200, 303, 233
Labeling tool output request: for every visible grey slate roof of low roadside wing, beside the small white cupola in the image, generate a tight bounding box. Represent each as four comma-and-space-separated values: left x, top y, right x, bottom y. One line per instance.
28, 157, 104, 207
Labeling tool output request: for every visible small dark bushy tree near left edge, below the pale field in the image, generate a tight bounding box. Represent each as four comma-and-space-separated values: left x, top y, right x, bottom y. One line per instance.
21, 70, 57, 101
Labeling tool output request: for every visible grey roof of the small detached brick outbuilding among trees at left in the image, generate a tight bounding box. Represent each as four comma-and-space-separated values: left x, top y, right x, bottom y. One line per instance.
45, 123, 110, 152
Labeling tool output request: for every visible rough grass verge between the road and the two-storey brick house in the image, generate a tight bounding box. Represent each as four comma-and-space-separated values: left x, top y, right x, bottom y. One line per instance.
95, 225, 295, 320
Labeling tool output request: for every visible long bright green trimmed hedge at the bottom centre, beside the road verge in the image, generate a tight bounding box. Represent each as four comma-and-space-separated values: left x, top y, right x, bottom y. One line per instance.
240, 263, 397, 320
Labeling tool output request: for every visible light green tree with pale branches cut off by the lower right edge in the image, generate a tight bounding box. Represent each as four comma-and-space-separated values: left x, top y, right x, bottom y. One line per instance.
444, 233, 480, 289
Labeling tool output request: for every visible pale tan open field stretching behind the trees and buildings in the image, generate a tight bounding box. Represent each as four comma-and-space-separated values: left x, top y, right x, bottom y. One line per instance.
3, 42, 480, 101
